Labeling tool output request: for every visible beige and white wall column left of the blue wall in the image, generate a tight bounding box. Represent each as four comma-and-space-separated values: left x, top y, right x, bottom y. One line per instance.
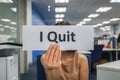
18, 0, 32, 74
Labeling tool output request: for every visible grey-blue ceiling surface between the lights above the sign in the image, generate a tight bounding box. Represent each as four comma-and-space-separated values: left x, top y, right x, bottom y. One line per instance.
32, 0, 120, 25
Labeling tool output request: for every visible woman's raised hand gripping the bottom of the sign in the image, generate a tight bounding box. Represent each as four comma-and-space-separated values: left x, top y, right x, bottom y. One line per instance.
41, 44, 61, 69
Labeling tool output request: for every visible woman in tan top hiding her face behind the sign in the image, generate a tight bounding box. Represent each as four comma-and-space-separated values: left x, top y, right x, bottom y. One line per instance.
41, 21, 88, 80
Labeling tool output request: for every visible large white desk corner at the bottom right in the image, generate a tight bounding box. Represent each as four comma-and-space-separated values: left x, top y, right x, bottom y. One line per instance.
97, 60, 120, 80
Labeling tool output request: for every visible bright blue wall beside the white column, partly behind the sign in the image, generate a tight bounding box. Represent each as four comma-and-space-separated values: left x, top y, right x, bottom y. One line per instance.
32, 4, 45, 61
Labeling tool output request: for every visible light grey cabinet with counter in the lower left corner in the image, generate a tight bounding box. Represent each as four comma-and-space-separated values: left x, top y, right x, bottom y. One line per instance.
0, 43, 21, 80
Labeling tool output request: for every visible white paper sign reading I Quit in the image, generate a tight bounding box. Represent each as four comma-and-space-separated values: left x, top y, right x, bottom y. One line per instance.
23, 26, 94, 50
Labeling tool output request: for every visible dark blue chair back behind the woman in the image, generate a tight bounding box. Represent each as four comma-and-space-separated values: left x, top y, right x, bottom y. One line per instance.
37, 51, 91, 80
